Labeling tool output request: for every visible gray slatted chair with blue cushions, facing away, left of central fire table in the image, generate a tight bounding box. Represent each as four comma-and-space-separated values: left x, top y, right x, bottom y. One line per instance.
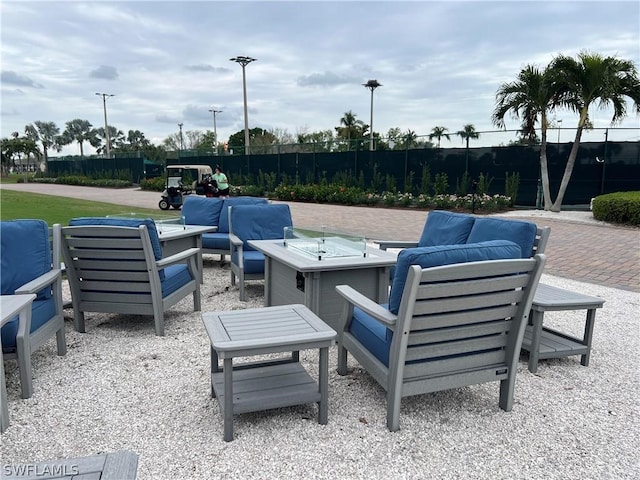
60, 218, 200, 335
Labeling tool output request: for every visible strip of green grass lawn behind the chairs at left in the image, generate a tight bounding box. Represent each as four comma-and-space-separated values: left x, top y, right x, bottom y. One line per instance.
0, 189, 158, 225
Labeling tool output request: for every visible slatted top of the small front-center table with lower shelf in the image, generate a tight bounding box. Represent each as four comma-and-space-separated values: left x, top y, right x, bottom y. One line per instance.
202, 304, 336, 353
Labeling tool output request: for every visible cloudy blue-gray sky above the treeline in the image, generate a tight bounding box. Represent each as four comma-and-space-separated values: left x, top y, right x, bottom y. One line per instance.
0, 0, 640, 154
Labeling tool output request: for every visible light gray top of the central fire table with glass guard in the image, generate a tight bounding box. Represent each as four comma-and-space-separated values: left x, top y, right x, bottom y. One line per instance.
248, 240, 398, 272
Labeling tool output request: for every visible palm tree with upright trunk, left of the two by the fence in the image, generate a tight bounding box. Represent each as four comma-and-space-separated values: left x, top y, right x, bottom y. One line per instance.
492, 65, 555, 210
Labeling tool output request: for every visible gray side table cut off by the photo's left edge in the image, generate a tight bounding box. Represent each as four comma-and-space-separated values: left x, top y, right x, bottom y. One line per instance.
0, 293, 36, 432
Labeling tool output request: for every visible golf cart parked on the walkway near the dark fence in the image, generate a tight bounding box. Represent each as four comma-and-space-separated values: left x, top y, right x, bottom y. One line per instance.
158, 165, 213, 210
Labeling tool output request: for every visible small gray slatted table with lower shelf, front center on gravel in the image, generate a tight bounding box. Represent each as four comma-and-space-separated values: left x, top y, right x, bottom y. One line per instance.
202, 305, 336, 442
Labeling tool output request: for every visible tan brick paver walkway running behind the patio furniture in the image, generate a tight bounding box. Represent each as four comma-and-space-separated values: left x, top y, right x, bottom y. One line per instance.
0, 183, 640, 292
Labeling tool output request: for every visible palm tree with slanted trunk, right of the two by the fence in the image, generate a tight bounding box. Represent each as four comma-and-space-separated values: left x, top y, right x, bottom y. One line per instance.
549, 52, 640, 212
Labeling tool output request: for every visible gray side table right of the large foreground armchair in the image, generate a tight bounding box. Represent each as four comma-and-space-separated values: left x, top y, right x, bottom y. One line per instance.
522, 283, 604, 373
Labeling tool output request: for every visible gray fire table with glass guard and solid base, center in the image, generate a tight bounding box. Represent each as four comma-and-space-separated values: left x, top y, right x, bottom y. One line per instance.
248, 240, 397, 330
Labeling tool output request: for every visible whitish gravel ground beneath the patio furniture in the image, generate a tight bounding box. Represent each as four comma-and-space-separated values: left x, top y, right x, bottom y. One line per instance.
1, 256, 640, 480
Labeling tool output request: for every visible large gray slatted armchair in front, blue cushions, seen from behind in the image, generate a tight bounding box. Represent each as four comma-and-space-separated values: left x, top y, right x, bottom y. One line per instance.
336, 241, 545, 431
